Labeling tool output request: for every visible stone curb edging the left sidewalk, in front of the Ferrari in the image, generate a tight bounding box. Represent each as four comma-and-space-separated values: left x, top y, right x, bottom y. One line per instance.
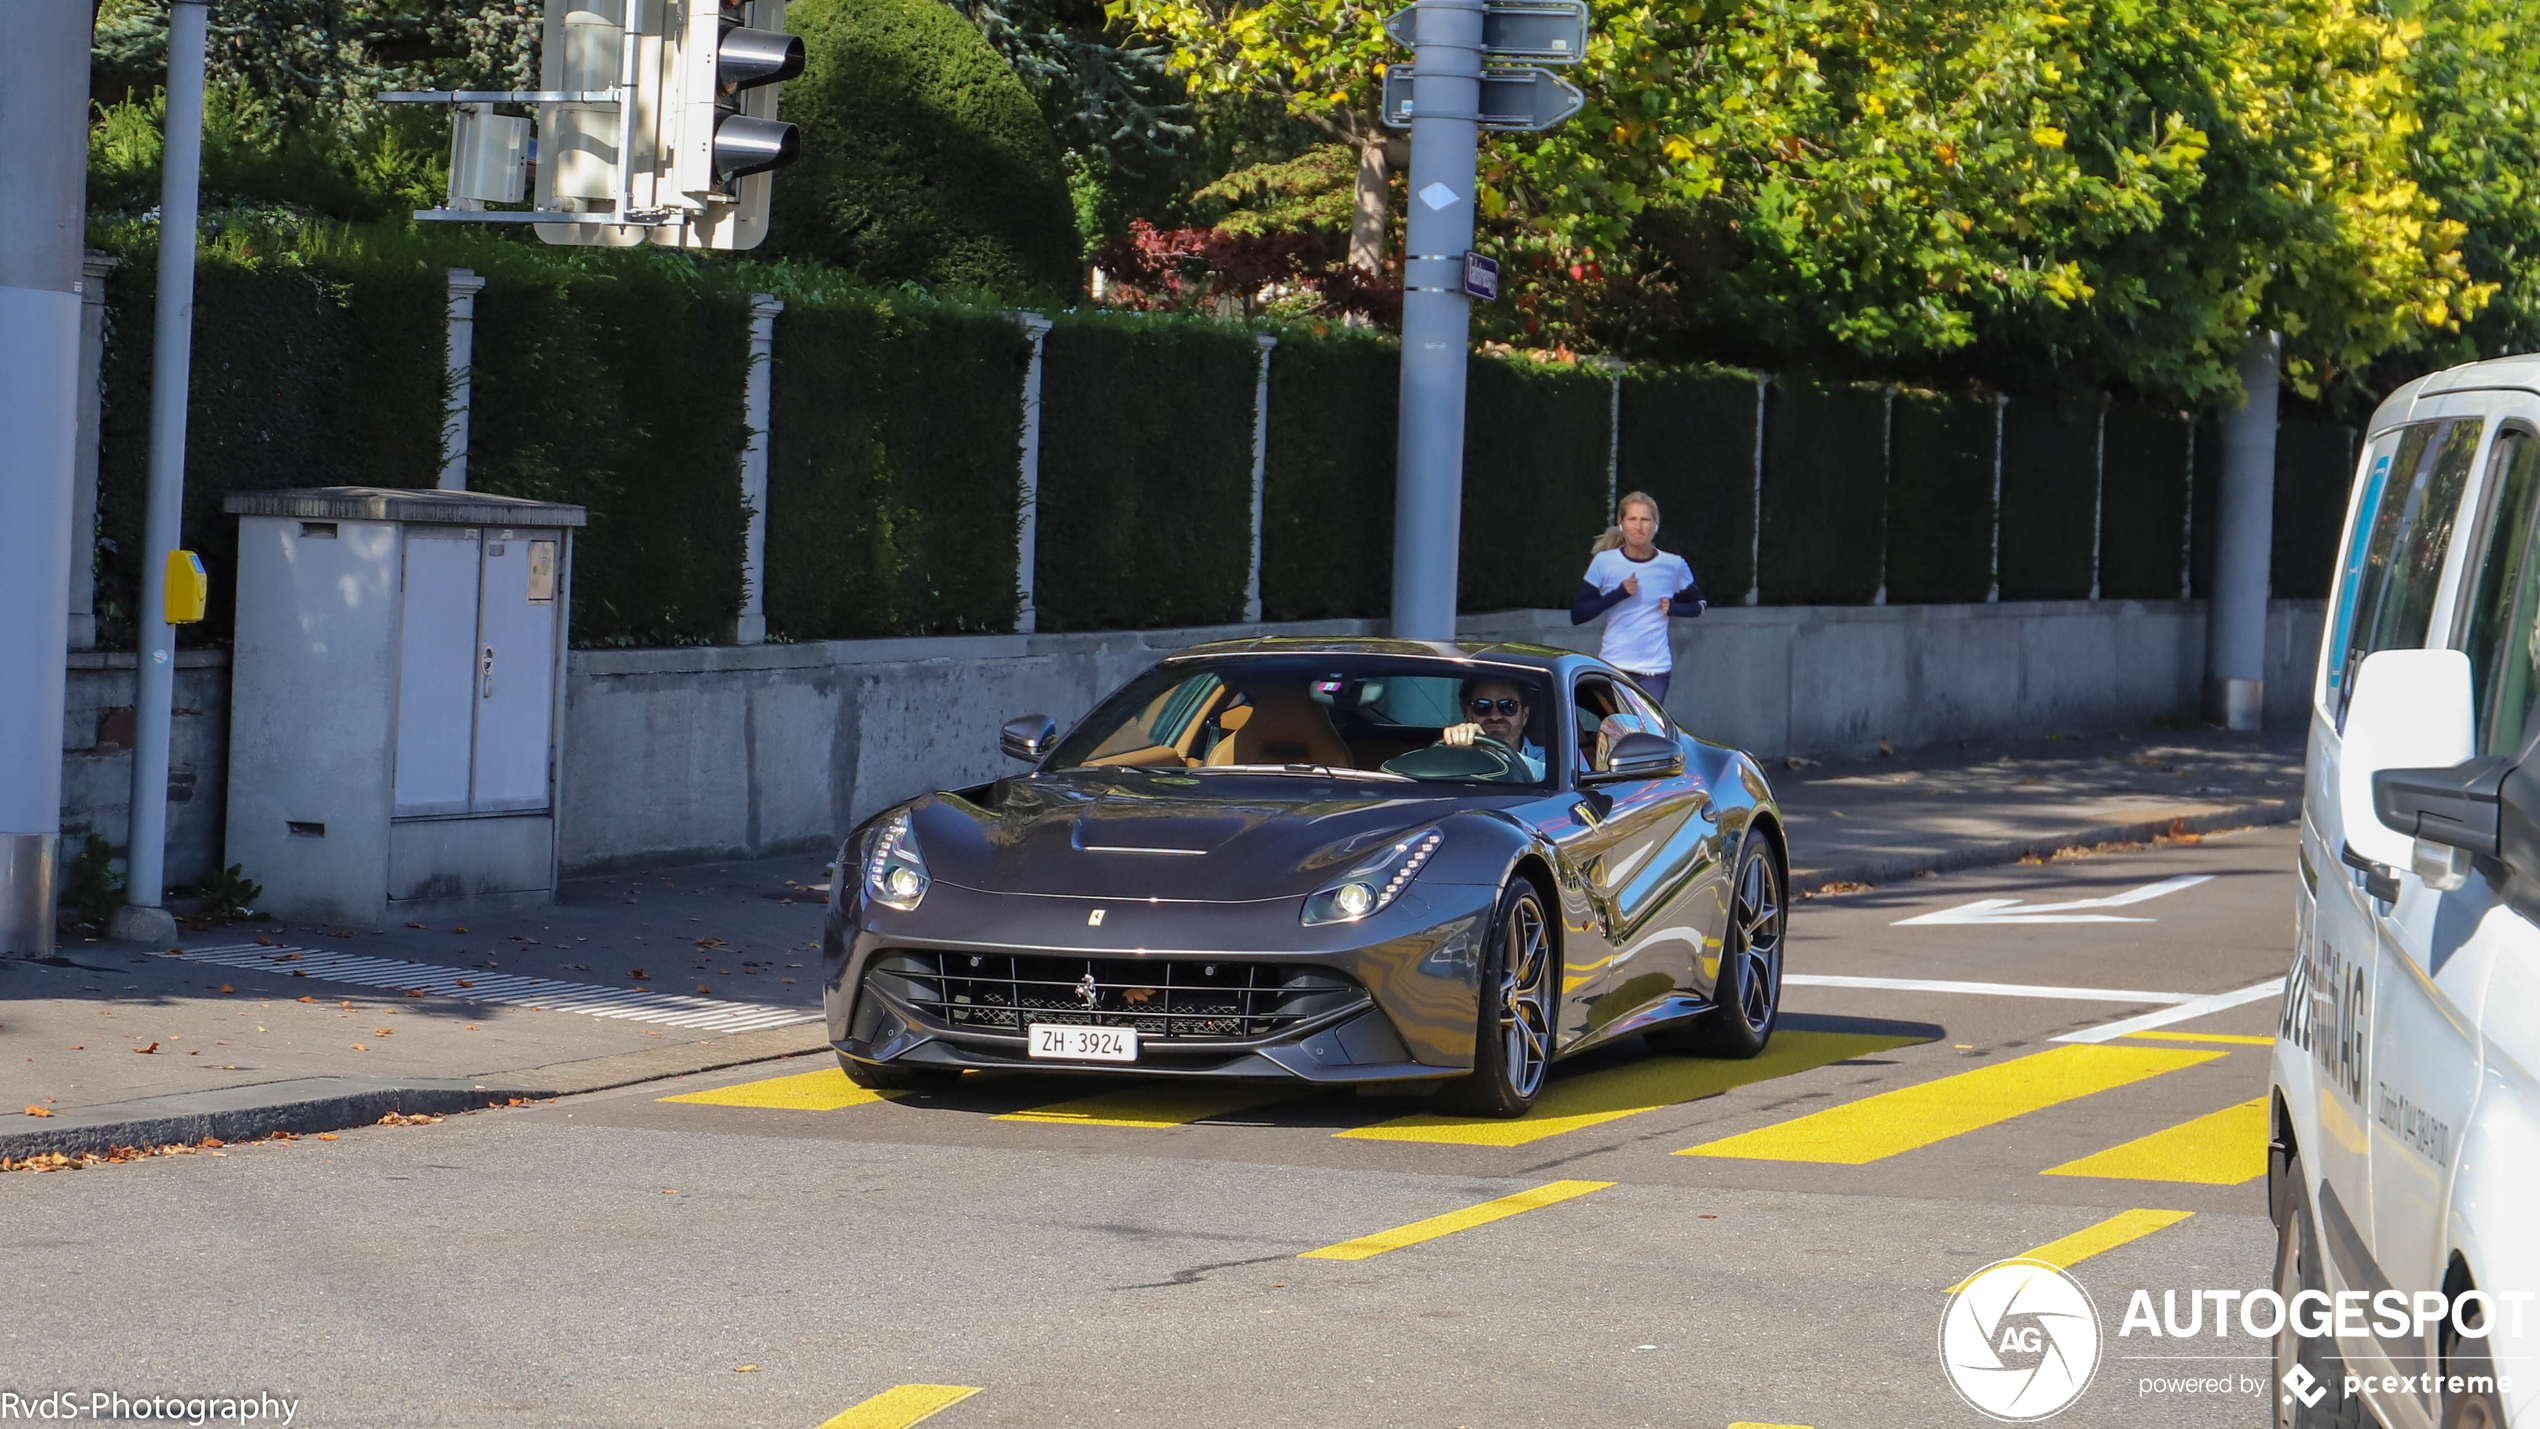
0, 1023, 828, 1160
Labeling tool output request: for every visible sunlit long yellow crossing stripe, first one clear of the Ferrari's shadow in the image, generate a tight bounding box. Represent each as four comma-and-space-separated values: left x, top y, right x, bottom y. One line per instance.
1676, 1043, 2230, 1165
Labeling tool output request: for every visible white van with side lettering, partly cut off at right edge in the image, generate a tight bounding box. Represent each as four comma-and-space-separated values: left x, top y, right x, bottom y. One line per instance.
2268, 358, 2540, 1429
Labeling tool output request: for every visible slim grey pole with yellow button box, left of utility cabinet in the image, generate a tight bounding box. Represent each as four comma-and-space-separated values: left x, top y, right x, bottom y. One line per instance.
107, 0, 208, 942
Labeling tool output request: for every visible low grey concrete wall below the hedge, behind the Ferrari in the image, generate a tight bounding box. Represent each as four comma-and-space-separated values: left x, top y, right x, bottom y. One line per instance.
561, 602, 2322, 873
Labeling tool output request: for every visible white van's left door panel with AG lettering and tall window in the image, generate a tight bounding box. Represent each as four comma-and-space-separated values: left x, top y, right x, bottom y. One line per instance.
2289, 416, 2484, 1373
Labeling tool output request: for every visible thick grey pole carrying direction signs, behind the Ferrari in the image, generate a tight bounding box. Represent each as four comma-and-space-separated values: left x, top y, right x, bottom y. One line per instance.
1394, 0, 1483, 640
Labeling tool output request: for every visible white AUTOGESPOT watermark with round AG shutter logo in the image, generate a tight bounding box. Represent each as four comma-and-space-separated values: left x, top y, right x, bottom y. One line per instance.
1941, 1259, 2540, 1424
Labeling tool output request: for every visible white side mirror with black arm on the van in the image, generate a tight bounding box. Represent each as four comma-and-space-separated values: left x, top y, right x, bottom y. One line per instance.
2337, 650, 2504, 886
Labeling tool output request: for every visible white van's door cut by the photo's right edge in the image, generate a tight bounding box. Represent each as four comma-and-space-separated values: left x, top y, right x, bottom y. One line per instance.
2357, 408, 2540, 1424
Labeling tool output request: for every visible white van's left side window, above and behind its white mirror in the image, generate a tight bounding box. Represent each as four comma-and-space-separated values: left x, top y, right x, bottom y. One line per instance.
2329, 416, 2487, 731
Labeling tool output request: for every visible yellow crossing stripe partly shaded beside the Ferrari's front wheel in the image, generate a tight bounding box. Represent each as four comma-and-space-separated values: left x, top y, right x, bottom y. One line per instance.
1334, 1031, 1923, 1147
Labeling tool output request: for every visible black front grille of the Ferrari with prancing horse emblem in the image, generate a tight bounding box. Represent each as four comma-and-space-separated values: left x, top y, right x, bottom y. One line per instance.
866, 949, 1367, 1041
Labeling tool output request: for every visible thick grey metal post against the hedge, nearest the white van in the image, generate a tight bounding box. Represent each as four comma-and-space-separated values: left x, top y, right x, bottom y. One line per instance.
2205, 333, 2283, 728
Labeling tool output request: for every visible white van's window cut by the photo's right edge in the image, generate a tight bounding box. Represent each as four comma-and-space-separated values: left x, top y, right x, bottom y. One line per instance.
2461, 429, 2540, 754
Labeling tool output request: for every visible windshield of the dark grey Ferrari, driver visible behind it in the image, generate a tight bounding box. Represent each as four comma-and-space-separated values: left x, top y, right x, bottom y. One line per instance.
1049, 655, 1552, 787
